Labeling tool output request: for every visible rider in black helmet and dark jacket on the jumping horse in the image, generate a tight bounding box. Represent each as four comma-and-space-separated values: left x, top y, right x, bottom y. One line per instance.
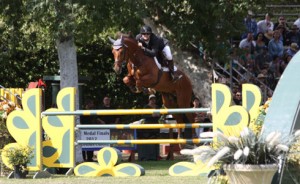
136, 25, 182, 81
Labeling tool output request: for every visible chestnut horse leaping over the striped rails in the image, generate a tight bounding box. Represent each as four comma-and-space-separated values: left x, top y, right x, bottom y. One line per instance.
110, 36, 194, 139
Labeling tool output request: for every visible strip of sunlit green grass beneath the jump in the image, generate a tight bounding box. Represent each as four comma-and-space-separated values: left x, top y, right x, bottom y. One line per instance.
0, 160, 207, 184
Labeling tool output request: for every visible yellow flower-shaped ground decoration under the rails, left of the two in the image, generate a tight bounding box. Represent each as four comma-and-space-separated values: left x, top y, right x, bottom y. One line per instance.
74, 147, 145, 176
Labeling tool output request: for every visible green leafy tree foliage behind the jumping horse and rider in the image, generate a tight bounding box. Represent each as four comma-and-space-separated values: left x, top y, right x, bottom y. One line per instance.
0, 0, 292, 113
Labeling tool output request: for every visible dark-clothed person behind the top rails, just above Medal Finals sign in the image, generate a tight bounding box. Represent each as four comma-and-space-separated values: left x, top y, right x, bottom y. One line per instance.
99, 96, 120, 124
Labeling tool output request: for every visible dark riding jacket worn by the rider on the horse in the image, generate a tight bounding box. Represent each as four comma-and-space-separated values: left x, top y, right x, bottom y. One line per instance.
136, 33, 168, 57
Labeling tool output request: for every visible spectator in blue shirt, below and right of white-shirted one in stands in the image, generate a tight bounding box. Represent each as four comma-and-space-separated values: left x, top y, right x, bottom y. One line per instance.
268, 30, 284, 57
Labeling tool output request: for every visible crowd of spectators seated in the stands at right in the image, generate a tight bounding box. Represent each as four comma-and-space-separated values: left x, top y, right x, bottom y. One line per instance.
218, 11, 300, 103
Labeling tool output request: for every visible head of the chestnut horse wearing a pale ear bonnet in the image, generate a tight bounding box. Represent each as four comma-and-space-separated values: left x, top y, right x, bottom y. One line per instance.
109, 37, 127, 74
